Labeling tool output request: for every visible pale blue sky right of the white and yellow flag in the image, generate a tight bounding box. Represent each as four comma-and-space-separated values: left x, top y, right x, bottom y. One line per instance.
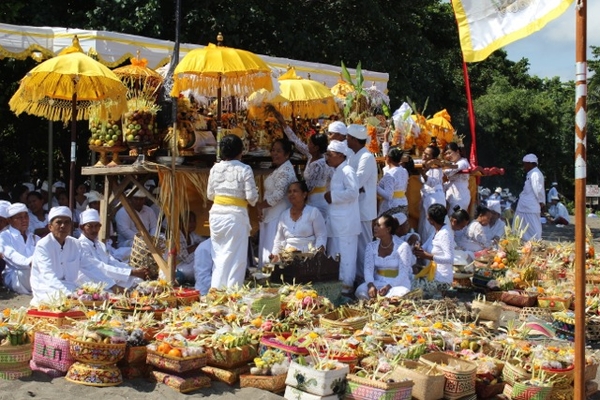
504, 0, 600, 81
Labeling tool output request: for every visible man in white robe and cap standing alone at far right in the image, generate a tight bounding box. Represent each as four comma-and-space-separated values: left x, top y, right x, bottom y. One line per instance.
513, 154, 546, 241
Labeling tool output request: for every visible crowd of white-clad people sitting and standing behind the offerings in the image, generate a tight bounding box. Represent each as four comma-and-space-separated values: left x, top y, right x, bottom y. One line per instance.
0, 117, 568, 304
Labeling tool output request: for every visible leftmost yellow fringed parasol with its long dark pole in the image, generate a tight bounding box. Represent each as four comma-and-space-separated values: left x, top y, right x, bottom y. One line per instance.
8, 37, 127, 209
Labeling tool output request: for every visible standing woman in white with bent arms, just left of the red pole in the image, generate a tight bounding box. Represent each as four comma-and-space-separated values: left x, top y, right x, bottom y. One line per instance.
444, 142, 471, 212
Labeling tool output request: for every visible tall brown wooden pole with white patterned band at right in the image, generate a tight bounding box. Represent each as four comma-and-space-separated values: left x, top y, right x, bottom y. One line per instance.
574, 0, 594, 399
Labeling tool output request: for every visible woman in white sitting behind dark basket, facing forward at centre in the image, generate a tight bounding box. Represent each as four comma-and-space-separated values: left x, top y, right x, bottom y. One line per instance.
272, 181, 327, 261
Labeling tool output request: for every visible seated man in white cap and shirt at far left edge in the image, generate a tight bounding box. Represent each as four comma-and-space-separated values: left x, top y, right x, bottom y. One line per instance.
0, 203, 40, 294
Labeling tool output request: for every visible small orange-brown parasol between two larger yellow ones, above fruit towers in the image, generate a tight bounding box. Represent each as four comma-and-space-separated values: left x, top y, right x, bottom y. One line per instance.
113, 51, 164, 99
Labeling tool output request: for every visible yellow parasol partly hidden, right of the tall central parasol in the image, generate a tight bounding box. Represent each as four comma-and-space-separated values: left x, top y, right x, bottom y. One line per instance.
278, 68, 339, 118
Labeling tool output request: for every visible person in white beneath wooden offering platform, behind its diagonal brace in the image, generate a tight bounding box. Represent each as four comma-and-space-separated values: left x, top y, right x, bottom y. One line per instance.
115, 190, 157, 247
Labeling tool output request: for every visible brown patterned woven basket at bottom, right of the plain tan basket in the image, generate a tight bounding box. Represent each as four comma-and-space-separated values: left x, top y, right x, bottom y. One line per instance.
419, 352, 477, 400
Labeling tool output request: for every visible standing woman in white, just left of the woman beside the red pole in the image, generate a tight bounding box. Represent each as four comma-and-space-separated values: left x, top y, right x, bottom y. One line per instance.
419, 146, 446, 242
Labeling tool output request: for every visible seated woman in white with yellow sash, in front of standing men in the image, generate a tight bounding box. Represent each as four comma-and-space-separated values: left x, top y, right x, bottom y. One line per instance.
356, 215, 416, 299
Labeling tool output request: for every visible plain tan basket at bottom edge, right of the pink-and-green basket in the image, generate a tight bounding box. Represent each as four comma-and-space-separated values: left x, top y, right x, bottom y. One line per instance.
390, 360, 446, 400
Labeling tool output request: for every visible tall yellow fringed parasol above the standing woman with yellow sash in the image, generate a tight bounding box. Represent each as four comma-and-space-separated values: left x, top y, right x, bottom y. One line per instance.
171, 33, 273, 122
